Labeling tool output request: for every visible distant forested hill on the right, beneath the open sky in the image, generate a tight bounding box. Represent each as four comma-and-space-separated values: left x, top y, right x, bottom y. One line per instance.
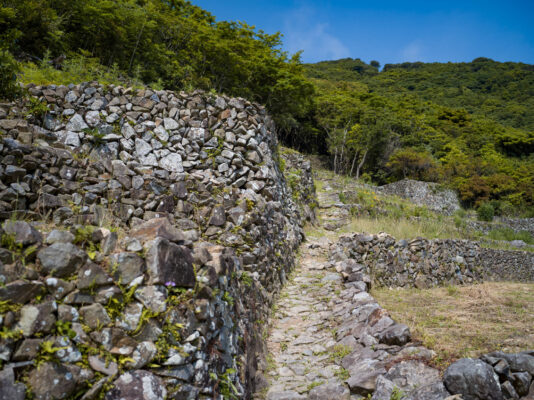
306, 58, 534, 212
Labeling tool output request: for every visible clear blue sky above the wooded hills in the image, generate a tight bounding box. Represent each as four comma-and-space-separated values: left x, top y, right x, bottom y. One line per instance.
192, 0, 534, 65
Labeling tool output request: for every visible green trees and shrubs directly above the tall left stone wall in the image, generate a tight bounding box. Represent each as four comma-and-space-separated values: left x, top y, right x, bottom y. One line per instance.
0, 0, 314, 139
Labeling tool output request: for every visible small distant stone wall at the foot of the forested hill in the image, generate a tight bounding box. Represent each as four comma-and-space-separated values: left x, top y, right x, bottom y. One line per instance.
376, 179, 460, 215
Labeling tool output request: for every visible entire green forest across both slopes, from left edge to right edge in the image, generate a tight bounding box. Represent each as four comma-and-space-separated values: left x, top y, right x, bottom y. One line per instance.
0, 0, 534, 212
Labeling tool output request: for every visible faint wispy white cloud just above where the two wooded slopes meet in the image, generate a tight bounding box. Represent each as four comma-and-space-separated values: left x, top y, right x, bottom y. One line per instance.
284, 7, 350, 62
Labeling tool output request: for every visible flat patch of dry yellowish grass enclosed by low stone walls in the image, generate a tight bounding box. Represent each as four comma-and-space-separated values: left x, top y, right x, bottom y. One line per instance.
372, 282, 534, 367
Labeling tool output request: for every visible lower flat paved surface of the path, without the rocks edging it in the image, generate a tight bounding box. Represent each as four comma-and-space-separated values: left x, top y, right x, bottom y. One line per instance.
258, 231, 350, 400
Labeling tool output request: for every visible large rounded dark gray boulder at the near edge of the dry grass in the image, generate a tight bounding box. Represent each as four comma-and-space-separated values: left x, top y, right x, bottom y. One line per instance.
443, 358, 503, 400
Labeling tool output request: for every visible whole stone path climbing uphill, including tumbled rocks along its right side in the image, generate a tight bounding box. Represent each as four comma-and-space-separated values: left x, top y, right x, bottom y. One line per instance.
254, 172, 448, 400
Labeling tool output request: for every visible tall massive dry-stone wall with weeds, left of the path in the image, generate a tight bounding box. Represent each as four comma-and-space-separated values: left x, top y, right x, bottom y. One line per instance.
0, 83, 313, 399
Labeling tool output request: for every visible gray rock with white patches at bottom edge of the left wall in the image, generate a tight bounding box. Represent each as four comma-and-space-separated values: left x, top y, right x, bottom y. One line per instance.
105, 370, 167, 400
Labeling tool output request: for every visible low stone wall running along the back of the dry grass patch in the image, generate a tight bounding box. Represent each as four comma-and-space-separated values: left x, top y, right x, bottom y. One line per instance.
332, 233, 534, 288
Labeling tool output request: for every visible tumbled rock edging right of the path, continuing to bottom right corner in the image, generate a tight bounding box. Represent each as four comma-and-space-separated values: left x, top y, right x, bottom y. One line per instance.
325, 248, 534, 400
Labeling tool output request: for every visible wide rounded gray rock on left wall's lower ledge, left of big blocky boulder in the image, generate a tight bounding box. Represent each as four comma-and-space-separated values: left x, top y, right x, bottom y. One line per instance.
37, 243, 87, 278
